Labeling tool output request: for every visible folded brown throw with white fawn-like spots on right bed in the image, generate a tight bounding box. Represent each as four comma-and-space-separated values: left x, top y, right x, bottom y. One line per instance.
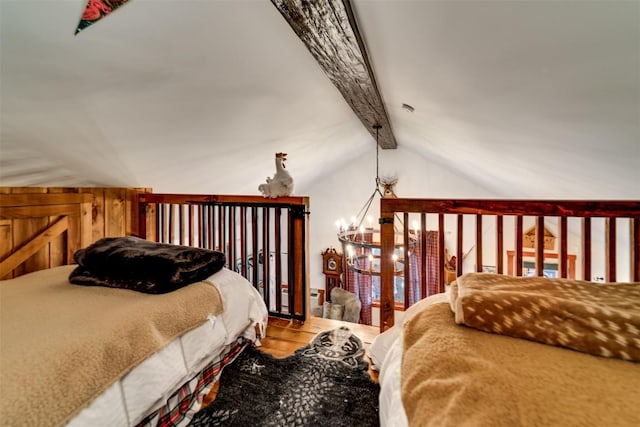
451, 273, 640, 362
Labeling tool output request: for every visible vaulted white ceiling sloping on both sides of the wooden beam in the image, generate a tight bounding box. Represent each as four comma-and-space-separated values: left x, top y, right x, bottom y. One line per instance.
0, 0, 640, 199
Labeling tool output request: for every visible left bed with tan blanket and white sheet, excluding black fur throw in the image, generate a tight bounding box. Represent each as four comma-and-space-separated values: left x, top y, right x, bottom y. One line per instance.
0, 265, 267, 426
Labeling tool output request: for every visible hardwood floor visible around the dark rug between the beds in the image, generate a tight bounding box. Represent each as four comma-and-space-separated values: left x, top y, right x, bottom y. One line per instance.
203, 317, 380, 406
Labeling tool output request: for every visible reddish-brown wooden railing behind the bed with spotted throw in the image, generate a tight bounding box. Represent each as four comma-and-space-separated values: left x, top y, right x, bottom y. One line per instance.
380, 198, 640, 331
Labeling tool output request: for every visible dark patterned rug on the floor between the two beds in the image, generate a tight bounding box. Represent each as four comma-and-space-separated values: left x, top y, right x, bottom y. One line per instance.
190, 328, 380, 427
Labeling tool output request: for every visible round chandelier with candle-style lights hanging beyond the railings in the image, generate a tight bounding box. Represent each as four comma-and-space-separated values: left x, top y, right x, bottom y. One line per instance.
336, 125, 418, 290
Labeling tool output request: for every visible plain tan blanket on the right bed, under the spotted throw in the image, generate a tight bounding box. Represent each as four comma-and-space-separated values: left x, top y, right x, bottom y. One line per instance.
402, 303, 640, 427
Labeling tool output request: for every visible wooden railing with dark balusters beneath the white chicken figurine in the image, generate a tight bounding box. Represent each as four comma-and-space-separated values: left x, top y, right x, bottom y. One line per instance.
138, 194, 309, 320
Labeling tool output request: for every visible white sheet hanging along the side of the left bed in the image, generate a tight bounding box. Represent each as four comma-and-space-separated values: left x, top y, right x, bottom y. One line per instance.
68, 268, 268, 427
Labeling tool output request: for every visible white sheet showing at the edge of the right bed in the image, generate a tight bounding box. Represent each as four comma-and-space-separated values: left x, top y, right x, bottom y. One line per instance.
370, 294, 449, 427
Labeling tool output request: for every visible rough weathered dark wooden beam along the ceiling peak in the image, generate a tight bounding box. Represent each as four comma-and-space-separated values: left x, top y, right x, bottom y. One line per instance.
271, 0, 398, 148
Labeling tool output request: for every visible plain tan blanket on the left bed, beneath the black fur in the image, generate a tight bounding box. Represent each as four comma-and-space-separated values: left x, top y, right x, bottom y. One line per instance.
0, 266, 222, 426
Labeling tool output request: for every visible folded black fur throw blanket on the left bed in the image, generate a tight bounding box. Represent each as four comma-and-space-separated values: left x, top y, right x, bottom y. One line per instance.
69, 237, 226, 294
